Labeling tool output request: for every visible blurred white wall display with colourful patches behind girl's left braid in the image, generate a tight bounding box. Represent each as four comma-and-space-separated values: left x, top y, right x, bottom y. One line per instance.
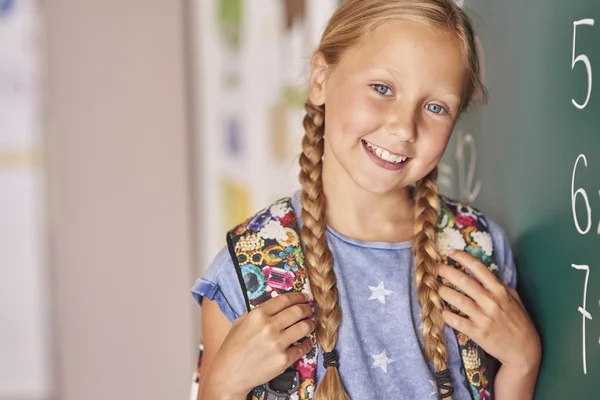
193, 0, 338, 272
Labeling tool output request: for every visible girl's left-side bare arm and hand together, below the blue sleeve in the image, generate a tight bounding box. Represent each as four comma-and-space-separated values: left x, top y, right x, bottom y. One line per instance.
198, 292, 315, 400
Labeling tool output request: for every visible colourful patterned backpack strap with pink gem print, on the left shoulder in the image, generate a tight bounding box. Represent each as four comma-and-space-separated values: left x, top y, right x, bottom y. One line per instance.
227, 198, 318, 400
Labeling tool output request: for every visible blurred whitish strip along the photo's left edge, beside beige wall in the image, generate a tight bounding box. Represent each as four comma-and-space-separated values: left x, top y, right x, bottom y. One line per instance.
0, 0, 51, 400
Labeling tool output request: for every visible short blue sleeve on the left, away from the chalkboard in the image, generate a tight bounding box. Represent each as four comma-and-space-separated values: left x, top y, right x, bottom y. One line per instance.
191, 247, 246, 322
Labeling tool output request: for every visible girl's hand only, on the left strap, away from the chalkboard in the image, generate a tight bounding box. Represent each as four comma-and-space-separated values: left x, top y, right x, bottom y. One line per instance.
206, 292, 315, 398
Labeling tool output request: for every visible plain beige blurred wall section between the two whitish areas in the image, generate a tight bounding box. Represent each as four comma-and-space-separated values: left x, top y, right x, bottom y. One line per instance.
43, 0, 197, 400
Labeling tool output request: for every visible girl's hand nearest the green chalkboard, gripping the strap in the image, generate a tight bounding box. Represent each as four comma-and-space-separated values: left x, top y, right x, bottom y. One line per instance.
439, 251, 541, 374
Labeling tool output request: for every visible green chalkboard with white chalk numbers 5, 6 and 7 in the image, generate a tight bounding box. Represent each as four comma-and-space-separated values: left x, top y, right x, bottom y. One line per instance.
440, 0, 600, 400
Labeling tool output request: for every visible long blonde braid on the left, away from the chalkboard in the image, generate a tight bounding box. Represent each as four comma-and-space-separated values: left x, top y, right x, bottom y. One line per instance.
300, 100, 349, 400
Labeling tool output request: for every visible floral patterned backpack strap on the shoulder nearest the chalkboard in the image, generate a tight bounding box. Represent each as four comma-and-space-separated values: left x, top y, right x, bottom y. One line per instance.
436, 196, 500, 400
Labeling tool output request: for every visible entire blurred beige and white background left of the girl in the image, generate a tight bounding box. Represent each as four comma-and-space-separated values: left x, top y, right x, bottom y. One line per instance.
0, 0, 339, 400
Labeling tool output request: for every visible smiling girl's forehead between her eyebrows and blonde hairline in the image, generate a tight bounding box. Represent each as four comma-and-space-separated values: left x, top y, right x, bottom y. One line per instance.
338, 20, 467, 92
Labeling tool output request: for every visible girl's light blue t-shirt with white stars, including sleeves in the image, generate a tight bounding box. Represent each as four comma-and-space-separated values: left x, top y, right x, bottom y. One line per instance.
192, 192, 516, 400
